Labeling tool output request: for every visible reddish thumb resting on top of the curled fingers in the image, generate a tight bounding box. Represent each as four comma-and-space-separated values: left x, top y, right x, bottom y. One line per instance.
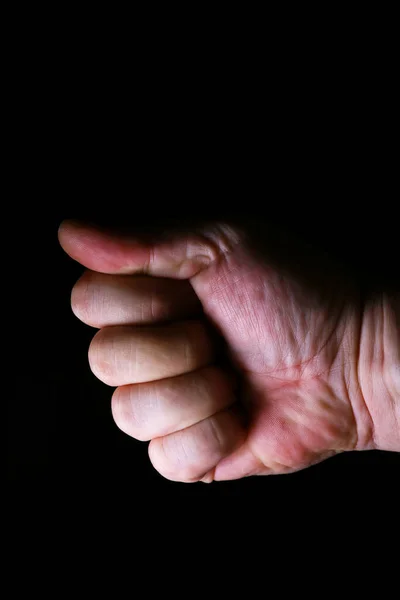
58, 220, 236, 279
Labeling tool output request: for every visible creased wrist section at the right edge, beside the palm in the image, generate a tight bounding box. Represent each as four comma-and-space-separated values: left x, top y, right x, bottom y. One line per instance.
358, 292, 400, 452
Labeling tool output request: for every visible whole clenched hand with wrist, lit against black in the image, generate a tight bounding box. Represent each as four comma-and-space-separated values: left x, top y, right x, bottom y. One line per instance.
59, 221, 400, 482
